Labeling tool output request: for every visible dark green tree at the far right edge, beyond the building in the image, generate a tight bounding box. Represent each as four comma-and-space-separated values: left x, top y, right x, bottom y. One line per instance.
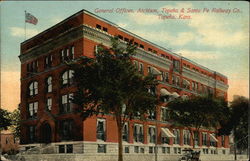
219, 96, 249, 151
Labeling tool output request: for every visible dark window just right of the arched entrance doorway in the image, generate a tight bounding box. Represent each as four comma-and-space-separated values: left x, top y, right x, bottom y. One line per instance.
60, 120, 73, 140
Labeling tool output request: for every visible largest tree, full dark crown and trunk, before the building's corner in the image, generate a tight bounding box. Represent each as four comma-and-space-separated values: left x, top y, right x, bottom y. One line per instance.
70, 37, 157, 161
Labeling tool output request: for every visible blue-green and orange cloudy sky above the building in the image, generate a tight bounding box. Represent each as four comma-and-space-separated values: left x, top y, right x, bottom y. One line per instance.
0, 1, 249, 111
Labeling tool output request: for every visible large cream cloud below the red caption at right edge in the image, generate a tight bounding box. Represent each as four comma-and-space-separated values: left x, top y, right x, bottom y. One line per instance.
188, 13, 248, 47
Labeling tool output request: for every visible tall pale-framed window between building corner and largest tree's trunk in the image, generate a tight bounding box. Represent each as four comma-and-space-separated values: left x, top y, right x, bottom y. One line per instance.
96, 119, 106, 141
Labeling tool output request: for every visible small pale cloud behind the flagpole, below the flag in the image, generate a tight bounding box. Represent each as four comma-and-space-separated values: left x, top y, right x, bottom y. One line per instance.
10, 27, 39, 37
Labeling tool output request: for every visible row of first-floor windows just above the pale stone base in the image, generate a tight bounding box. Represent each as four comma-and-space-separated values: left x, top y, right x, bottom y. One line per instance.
26, 119, 225, 147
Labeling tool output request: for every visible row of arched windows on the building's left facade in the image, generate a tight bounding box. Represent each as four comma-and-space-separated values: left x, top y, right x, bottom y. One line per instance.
28, 70, 74, 96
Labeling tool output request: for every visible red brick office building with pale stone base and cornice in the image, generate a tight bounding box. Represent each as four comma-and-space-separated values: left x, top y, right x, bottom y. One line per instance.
20, 10, 229, 157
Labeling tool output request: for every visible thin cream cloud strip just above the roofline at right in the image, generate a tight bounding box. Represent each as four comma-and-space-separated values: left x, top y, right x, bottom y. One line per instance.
176, 50, 219, 60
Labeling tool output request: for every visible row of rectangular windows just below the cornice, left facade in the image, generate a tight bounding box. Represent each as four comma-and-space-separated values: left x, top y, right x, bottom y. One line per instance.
27, 45, 75, 76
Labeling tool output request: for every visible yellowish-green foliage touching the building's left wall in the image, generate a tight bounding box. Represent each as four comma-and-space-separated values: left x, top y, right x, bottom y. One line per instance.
9, 108, 21, 138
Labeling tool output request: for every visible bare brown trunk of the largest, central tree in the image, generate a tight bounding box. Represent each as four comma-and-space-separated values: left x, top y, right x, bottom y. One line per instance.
116, 116, 123, 161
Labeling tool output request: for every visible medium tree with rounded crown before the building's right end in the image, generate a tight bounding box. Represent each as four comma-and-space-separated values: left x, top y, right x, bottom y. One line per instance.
168, 96, 228, 148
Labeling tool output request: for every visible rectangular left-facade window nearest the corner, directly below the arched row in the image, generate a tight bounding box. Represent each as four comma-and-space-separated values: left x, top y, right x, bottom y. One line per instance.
61, 93, 73, 113
